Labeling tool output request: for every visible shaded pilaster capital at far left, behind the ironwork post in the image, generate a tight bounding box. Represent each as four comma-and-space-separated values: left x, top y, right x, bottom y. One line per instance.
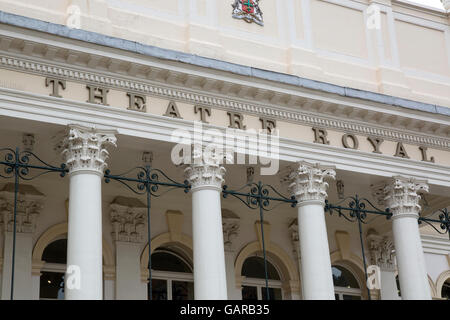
0, 183, 44, 233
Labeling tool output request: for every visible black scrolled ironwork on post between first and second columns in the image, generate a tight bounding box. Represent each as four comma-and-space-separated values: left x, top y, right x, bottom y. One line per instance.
104, 166, 191, 300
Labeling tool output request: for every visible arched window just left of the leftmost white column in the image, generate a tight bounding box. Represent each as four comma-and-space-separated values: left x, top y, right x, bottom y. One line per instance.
39, 239, 67, 300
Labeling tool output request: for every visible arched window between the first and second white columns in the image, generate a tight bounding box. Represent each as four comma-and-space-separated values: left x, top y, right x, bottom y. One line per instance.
152, 248, 194, 300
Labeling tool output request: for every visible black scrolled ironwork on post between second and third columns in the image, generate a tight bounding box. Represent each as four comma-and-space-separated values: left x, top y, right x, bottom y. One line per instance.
222, 181, 297, 300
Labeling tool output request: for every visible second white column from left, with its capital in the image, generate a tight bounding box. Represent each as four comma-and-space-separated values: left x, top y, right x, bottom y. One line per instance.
186, 159, 227, 300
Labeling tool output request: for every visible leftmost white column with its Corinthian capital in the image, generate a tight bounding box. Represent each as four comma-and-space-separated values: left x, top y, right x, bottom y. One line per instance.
62, 126, 116, 300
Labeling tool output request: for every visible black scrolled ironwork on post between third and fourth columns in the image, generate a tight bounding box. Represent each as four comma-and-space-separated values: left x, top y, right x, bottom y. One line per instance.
325, 195, 392, 300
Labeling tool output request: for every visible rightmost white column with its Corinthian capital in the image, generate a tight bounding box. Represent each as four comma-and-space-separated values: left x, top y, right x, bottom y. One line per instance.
385, 176, 431, 300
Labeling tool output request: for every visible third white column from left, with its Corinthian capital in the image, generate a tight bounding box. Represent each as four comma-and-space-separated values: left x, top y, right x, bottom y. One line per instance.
289, 162, 336, 300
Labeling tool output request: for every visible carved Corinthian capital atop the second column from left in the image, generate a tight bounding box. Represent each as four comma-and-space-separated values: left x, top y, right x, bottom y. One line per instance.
184, 147, 226, 190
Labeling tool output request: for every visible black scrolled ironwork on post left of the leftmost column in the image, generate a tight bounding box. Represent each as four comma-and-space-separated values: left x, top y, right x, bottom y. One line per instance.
0, 148, 68, 300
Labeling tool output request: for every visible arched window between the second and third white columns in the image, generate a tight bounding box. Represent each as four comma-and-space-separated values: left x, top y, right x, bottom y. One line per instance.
241, 256, 282, 300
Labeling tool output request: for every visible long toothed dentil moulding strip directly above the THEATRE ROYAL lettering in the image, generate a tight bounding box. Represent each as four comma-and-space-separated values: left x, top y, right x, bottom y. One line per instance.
0, 56, 450, 151
